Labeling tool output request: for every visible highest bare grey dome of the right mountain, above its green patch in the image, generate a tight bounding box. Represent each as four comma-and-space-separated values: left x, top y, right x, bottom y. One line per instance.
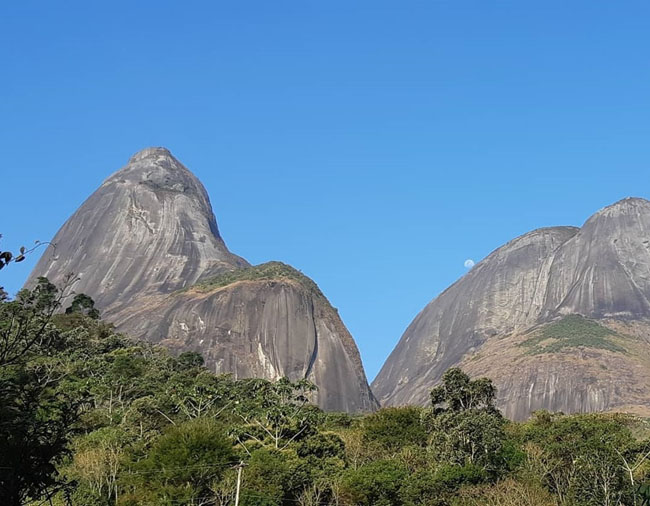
543, 198, 650, 319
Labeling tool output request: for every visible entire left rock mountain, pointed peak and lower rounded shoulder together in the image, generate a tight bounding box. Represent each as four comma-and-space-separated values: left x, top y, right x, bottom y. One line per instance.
28, 148, 377, 412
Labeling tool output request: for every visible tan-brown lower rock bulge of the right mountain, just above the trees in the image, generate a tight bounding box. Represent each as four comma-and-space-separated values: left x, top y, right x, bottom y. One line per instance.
458, 315, 650, 420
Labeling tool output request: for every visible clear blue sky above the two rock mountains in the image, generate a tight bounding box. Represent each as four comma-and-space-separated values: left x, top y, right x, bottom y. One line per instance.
0, 0, 650, 378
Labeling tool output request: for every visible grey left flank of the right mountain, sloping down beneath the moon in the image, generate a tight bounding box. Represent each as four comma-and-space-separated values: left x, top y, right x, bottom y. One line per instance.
373, 227, 577, 404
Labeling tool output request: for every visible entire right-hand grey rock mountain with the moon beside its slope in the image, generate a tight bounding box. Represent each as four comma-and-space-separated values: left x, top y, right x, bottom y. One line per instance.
373, 198, 650, 419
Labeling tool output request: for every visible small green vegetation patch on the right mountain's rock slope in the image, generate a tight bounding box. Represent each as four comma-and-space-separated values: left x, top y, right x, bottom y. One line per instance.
521, 315, 626, 355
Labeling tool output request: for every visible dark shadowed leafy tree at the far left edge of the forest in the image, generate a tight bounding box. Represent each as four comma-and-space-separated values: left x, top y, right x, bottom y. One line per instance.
0, 278, 85, 505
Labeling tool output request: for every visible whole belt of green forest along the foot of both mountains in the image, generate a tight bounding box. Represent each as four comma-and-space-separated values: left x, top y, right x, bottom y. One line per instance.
0, 278, 650, 506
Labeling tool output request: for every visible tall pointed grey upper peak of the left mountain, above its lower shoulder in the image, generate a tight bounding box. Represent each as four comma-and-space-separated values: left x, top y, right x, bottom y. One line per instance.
31, 148, 248, 317
